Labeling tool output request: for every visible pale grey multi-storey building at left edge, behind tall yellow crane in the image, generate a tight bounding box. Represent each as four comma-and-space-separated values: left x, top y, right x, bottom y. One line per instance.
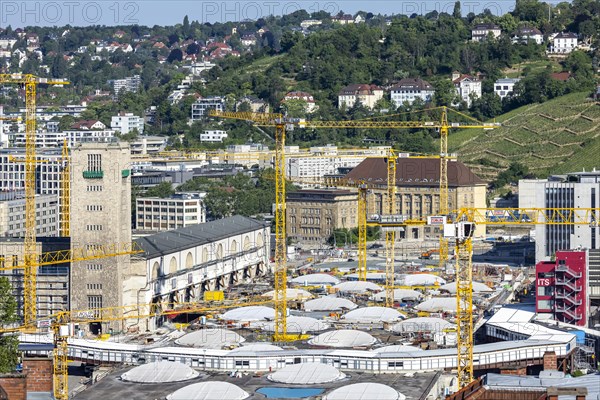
0, 191, 60, 237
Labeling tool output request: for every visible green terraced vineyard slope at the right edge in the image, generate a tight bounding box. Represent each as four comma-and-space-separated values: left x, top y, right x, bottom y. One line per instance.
448, 93, 600, 181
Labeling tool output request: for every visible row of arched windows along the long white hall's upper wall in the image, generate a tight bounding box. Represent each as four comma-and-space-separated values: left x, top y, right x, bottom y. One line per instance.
152, 232, 264, 280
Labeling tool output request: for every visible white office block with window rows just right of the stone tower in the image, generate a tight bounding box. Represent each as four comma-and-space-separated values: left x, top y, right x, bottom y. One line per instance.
136, 193, 206, 231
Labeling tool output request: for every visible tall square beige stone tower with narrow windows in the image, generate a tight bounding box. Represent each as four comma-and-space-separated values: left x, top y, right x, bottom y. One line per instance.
70, 143, 131, 332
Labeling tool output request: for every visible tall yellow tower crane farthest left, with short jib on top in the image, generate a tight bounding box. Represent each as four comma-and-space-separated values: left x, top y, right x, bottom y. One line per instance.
0, 74, 69, 327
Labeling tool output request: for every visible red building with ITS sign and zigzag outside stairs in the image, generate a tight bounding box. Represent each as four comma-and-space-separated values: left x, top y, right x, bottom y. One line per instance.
535, 251, 588, 326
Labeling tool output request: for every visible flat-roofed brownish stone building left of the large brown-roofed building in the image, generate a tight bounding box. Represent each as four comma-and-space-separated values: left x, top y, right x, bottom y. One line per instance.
286, 189, 358, 244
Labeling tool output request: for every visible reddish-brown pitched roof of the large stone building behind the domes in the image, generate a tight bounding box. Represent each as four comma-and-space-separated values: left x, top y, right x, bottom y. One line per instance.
344, 157, 485, 187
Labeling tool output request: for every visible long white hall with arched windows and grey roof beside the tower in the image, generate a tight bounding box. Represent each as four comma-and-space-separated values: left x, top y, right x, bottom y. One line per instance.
132, 215, 271, 329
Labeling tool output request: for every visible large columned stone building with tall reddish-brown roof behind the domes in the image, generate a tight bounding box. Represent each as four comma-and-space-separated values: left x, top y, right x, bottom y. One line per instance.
344, 157, 487, 239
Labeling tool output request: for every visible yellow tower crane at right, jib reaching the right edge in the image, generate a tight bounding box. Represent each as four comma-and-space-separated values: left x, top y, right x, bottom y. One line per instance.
372, 208, 600, 388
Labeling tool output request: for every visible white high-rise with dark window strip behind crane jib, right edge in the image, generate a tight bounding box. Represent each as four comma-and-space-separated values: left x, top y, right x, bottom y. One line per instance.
519, 170, 600, 261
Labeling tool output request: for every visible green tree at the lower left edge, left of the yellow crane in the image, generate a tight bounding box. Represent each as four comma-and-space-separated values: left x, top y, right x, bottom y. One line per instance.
0, 277, 19, 373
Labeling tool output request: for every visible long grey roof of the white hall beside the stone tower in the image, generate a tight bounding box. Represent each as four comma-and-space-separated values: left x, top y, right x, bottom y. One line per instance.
135, 215, 269, 259
